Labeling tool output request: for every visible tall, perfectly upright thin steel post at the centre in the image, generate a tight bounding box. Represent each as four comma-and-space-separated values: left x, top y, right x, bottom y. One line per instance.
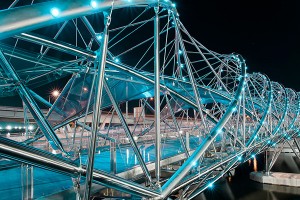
154, 5, 161, 185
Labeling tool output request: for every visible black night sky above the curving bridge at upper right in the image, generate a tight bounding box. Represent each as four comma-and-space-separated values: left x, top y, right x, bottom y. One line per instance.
175, 0, 300, 91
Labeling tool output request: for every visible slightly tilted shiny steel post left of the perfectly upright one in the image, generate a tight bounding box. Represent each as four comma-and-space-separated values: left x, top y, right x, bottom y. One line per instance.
83, 12, 111, 200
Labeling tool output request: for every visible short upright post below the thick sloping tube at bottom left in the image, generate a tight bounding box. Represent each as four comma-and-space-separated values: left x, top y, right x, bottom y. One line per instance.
21, 164, 33, 199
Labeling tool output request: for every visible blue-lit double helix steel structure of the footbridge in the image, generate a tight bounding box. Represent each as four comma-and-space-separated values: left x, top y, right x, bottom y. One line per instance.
0, 0, 300, 199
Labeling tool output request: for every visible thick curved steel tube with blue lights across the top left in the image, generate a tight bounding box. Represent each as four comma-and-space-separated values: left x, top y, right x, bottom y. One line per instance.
0, 0, 176, 40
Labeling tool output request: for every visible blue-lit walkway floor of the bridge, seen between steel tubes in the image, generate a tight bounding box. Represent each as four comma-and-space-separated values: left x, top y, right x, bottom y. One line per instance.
0, 137, 199, 200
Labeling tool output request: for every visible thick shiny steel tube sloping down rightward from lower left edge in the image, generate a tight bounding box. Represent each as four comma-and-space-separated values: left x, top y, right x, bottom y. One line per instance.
0, 137, 160, 198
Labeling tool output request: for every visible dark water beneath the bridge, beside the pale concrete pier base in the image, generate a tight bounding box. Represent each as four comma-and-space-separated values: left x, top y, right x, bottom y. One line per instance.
195, 155, 300, 200
